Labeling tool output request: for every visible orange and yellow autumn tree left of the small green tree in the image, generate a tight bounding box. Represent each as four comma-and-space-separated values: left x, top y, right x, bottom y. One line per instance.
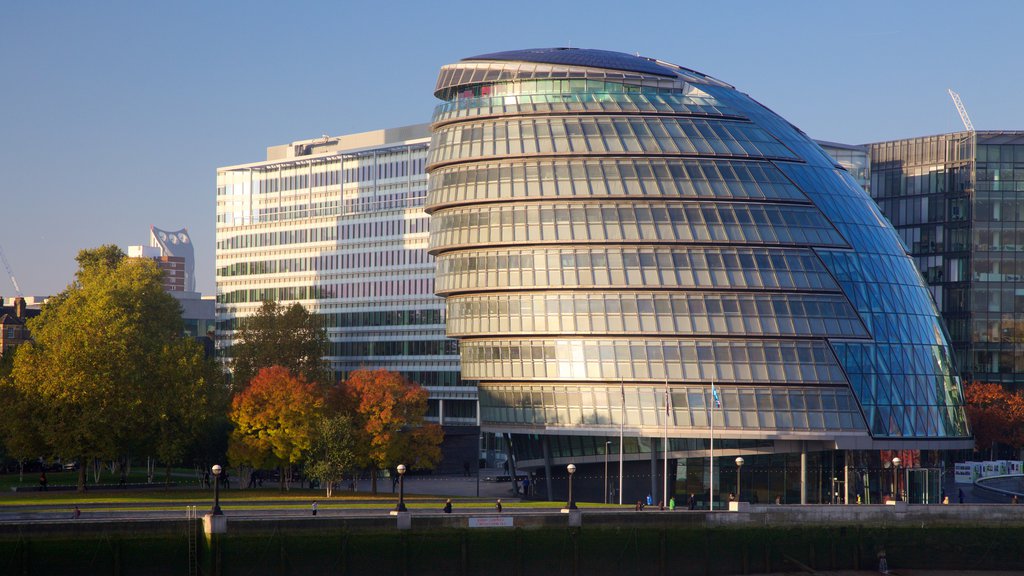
228, 366, 323, 491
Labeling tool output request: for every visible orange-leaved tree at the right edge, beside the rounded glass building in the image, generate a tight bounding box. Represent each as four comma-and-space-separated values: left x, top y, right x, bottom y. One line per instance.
964, 382, 1024, 459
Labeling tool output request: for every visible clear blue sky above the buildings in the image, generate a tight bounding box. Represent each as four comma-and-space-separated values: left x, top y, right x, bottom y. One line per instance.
0, 0, 1024, 296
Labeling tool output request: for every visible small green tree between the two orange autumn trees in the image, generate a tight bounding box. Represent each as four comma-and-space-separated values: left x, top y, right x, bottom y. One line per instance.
305, 414, 359, 498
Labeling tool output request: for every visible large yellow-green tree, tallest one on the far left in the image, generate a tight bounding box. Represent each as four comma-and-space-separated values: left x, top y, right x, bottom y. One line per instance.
12, 246, 192, 490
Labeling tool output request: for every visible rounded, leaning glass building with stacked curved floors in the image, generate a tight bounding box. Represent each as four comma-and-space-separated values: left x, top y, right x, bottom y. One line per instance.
426, 48, 972, 502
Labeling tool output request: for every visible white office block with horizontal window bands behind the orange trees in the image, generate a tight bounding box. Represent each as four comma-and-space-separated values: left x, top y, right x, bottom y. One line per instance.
216, 125, 477, 440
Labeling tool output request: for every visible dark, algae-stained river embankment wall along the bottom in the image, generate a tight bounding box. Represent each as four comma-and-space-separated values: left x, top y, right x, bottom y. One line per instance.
0, 504, 1024, 576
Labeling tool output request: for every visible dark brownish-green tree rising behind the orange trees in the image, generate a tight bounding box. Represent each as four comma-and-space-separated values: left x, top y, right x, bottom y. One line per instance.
230, 300, 330, 387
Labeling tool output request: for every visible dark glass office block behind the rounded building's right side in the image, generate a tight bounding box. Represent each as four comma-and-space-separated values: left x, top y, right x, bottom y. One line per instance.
868, 131, 1024, 390
